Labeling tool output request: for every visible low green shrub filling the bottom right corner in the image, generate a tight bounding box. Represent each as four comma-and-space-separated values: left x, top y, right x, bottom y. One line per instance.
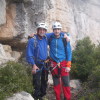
77, 66, 100, 100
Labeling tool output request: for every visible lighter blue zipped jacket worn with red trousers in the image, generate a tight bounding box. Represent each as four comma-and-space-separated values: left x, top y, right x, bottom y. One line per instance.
50, 33, 72, 63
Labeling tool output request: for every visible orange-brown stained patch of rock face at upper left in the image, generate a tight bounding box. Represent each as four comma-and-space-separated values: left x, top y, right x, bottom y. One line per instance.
0, 1, 17, 40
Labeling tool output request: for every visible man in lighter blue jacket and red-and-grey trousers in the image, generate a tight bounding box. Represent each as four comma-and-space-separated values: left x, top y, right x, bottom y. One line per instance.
49, 22, 72, 100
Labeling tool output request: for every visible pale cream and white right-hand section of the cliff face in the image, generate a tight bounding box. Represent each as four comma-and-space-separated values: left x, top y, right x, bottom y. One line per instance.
46, 0, 100, 46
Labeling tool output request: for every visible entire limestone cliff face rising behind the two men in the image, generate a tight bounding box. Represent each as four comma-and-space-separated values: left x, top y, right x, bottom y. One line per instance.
0, 0, 100, 47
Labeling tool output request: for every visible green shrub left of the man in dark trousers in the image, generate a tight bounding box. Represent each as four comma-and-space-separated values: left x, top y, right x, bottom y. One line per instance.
0, 62, 32, 100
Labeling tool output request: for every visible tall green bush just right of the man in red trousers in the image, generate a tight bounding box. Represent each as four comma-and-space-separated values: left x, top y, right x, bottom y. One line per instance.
71, 37, 100, 81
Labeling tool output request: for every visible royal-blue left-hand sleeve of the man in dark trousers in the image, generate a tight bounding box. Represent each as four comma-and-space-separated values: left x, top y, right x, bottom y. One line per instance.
26, 38, 35, 65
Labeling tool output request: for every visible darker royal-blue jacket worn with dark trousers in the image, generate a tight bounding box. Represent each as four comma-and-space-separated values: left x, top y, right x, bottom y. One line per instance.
26, 35, 48, 65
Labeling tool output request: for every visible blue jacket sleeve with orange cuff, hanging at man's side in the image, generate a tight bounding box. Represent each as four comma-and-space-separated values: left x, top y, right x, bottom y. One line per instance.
66, 42, 72, 67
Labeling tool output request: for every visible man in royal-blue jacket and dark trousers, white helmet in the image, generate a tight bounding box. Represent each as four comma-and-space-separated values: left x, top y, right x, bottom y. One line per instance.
26, 23, 48, 100
